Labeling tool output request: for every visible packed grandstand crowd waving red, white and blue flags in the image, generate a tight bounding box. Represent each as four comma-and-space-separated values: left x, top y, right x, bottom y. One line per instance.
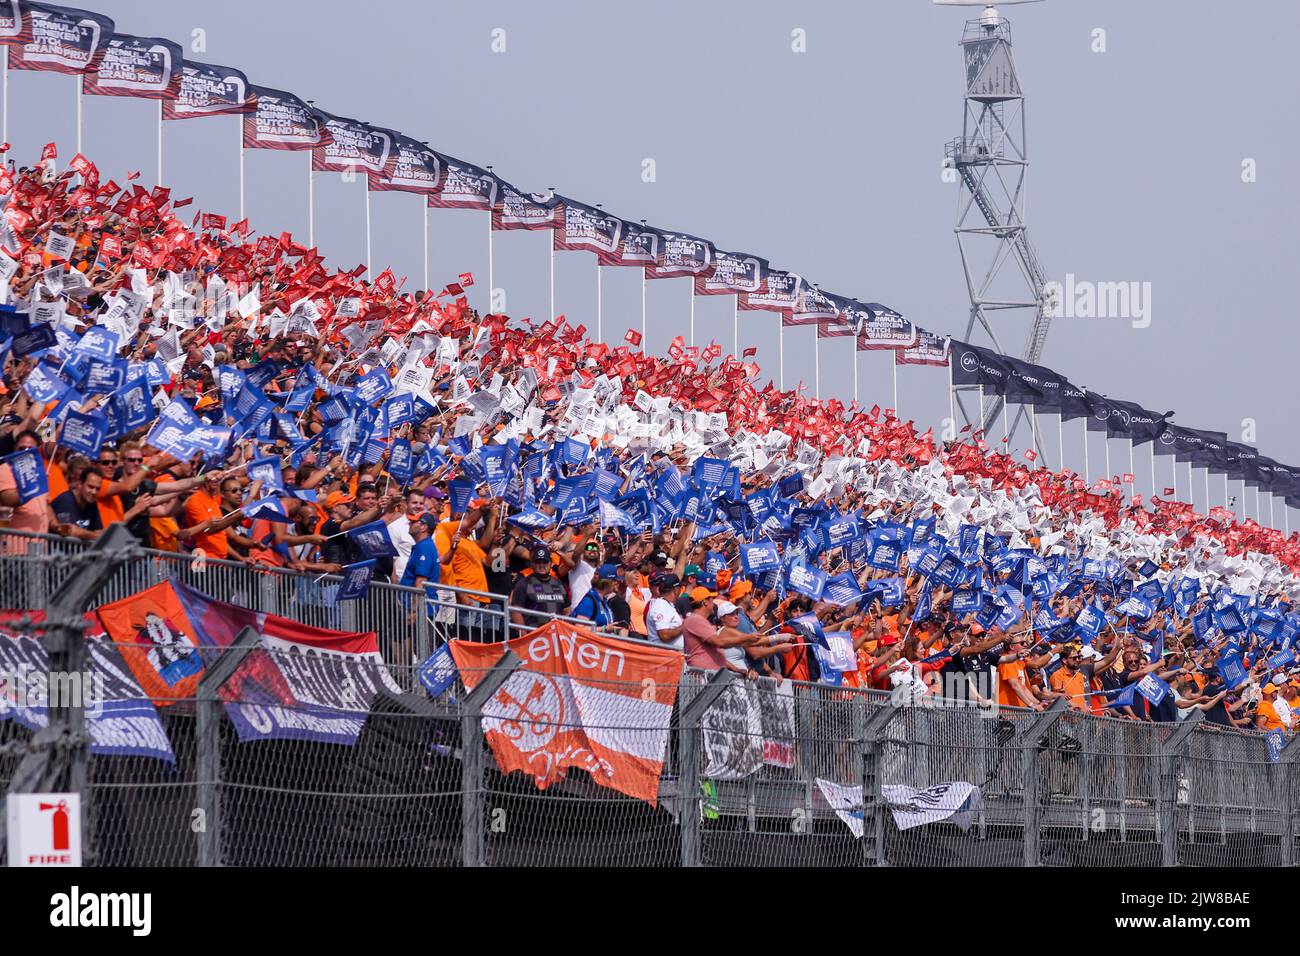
0, 147, 1300, 731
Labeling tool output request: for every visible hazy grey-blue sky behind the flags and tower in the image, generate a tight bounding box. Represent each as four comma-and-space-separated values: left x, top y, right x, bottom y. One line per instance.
9, 0, 1300, 512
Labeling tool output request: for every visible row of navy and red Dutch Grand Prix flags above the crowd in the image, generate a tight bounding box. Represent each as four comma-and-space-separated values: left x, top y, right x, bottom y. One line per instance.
0, 0, 946, 365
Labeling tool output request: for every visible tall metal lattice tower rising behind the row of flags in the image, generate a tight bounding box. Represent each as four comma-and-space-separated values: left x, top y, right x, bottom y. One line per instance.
933, 0, 1052, 454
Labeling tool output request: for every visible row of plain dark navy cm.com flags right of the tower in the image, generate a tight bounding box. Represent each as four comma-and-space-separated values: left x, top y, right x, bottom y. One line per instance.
952, 339, 1300, 507
